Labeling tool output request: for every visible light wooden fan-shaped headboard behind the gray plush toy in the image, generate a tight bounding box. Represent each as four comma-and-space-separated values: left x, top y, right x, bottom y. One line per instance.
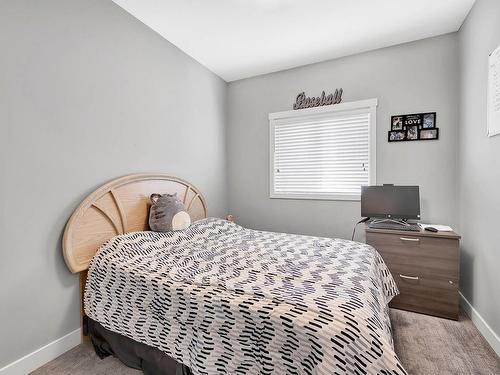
63, 174, 207, 273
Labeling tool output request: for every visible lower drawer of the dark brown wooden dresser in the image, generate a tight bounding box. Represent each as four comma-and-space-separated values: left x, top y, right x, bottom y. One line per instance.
390, 269, 459, 320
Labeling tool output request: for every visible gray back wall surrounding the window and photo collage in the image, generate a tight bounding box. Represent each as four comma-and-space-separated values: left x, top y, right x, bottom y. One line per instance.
227, 34, 459, 238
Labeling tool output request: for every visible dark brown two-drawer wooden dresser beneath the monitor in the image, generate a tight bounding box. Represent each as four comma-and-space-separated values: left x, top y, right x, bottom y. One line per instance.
365, 227, 460, 320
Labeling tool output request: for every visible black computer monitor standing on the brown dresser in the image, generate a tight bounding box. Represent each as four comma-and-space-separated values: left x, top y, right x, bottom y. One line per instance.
361, 185, 420, 219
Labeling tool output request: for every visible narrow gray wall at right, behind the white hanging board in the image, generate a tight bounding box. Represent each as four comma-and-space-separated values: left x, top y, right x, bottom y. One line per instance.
458, 0, 500, 335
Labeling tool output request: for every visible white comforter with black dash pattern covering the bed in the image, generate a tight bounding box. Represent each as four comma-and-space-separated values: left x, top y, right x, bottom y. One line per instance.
85, 219, 406, 375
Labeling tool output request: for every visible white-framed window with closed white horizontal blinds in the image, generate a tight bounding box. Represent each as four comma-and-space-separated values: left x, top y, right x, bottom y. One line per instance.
269, 99, 377, 200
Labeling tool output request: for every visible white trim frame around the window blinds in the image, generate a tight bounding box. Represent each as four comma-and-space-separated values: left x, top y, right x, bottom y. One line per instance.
269, 98, 378, 201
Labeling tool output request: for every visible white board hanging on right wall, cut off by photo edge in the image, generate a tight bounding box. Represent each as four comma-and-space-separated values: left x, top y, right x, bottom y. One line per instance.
487, 46, 500, 137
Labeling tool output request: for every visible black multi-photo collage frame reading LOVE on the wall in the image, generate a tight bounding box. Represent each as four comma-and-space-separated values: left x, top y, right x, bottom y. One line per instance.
388, 112, 439, 142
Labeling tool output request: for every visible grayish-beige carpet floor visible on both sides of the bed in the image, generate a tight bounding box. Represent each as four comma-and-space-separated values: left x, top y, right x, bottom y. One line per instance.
32, 310, 500, 375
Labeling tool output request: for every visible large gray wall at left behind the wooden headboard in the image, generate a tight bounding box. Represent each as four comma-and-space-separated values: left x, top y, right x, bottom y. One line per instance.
0, 0, 227, 368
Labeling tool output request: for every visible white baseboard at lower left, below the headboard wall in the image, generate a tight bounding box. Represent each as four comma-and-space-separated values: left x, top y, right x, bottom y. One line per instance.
0, 328, 82, 375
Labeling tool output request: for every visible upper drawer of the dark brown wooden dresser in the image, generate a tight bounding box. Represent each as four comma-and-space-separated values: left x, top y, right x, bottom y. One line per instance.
366, 232, 459, 283
